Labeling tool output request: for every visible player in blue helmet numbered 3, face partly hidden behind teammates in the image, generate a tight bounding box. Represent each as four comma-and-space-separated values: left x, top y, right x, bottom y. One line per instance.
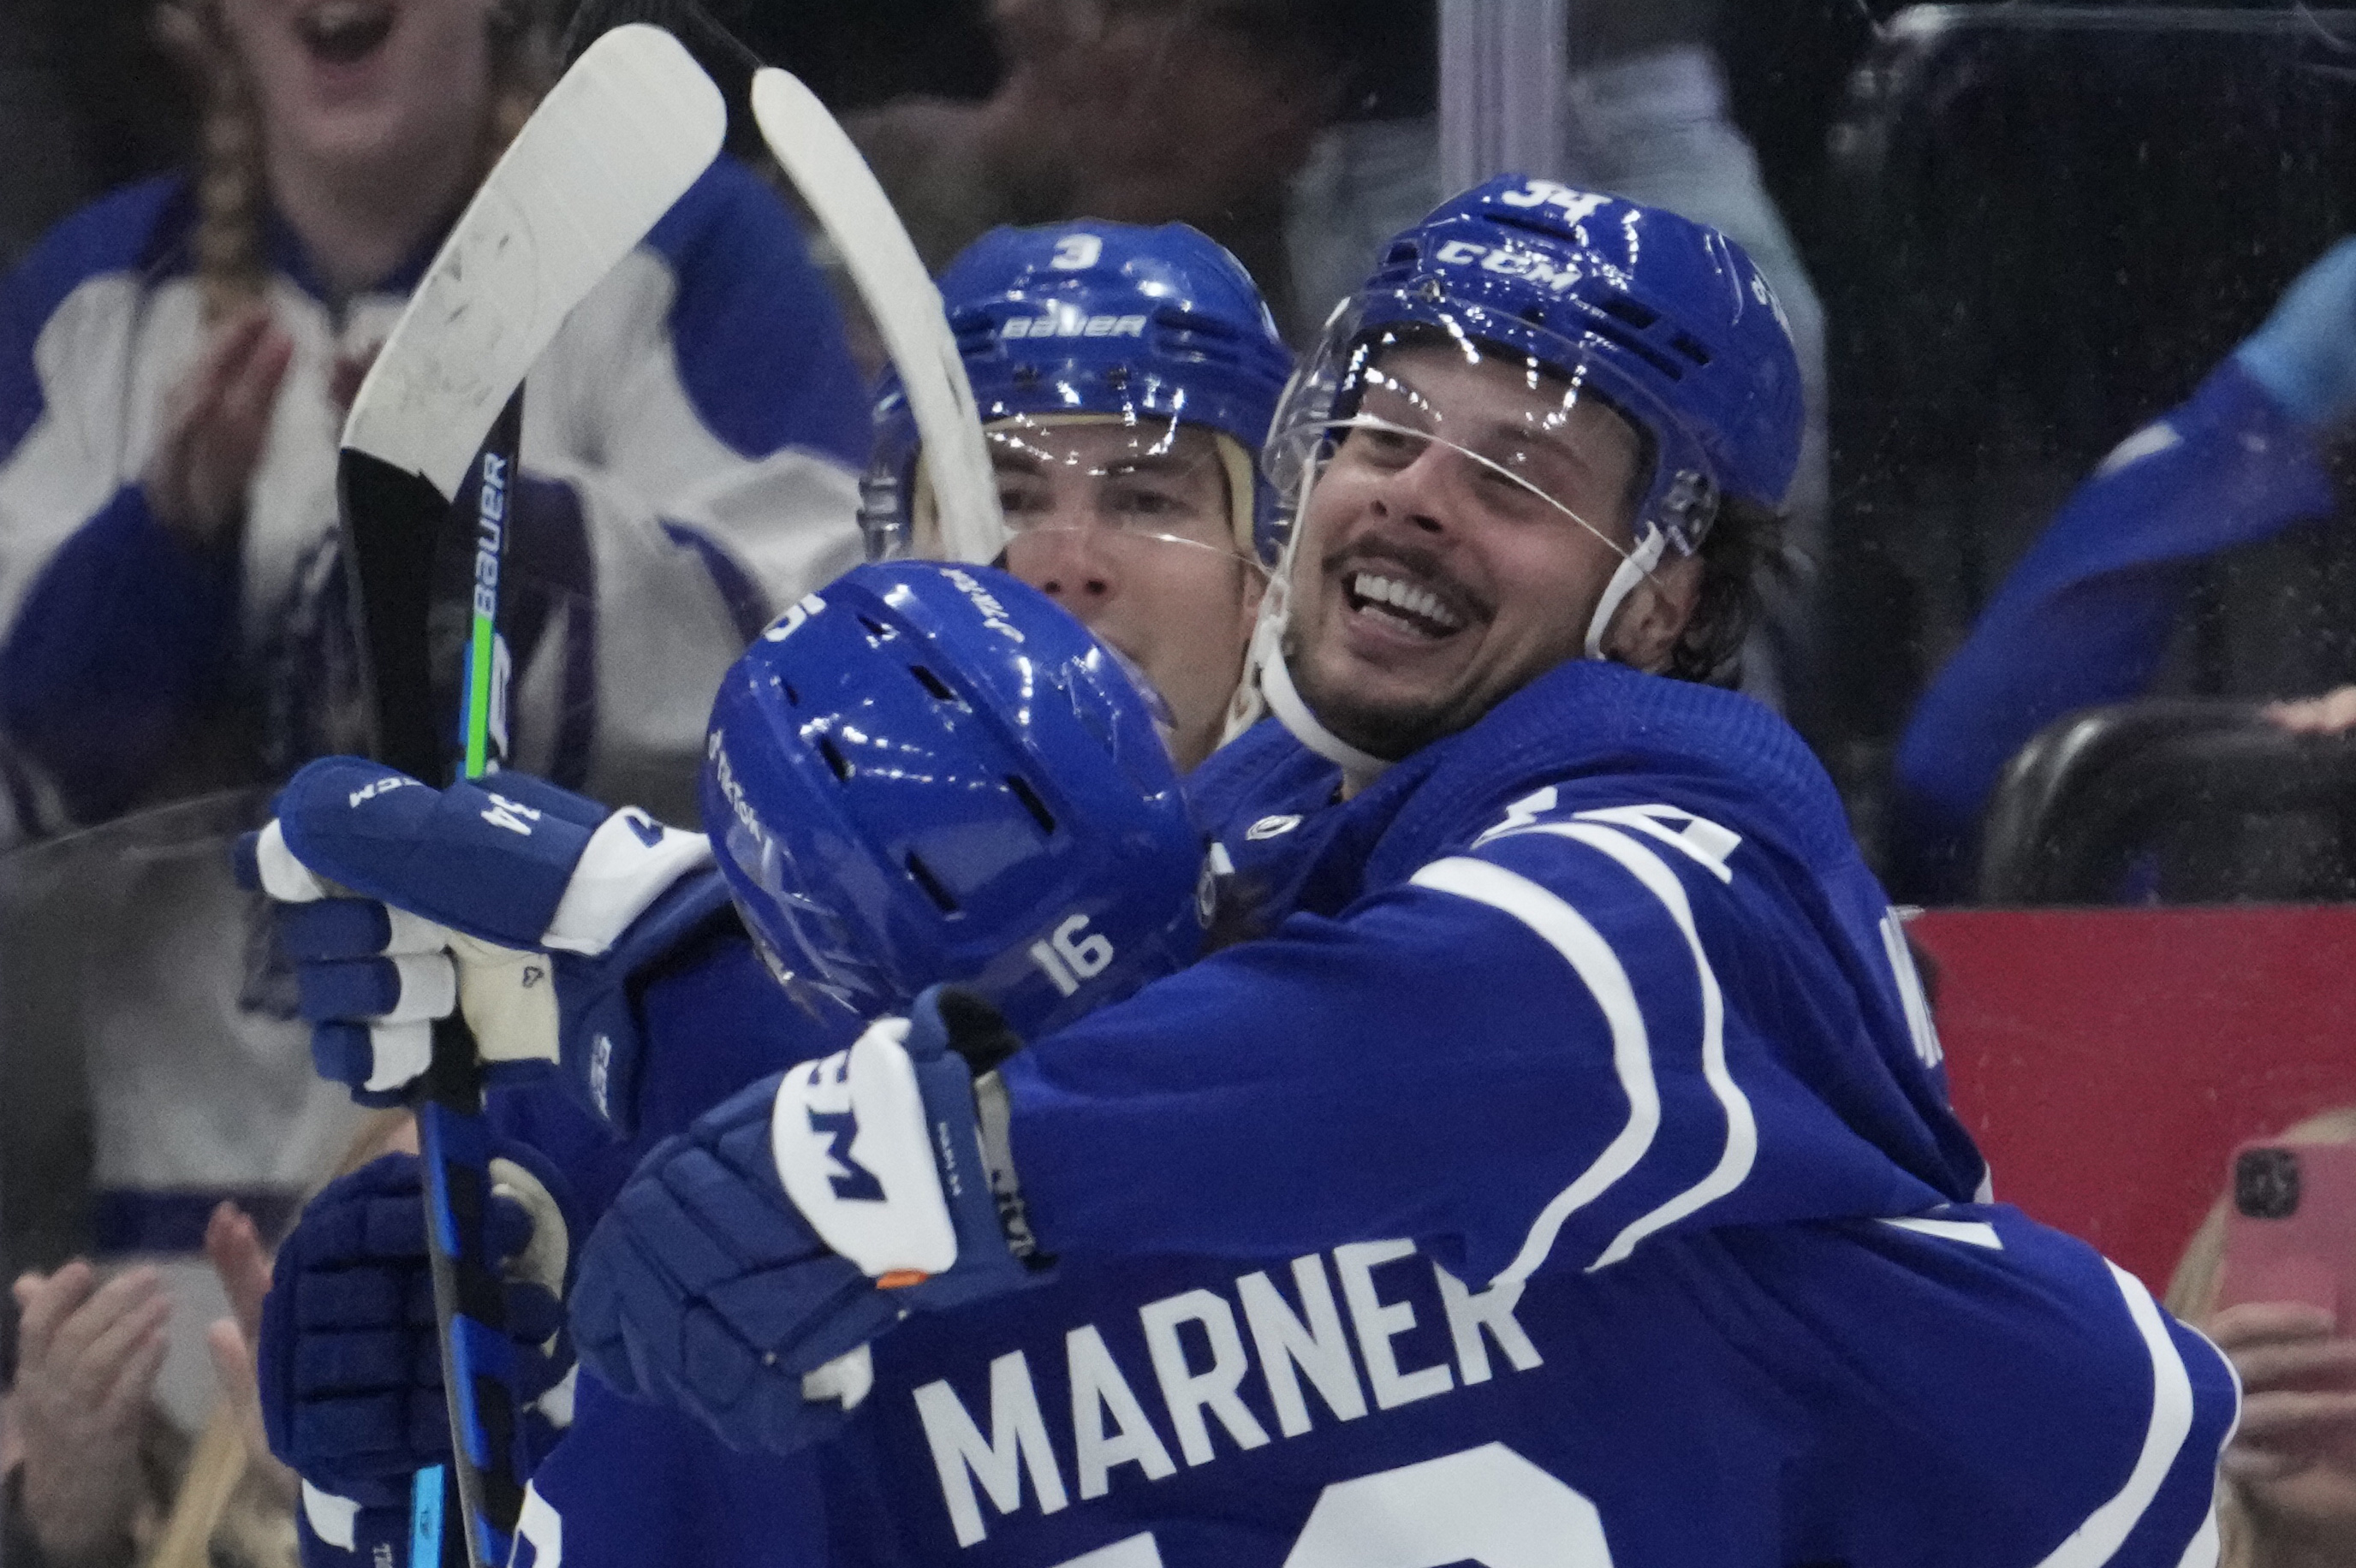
869, 222, 1291, 768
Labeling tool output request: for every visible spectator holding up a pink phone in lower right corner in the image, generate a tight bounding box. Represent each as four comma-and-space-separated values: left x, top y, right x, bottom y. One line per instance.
2168, 1109, 2356, 1568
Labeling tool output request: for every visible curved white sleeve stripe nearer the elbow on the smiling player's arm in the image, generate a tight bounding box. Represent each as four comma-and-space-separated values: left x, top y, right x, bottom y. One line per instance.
1413, 857, 1661, 1288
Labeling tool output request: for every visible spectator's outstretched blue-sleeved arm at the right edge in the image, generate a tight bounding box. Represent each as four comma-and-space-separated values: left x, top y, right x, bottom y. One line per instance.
1892, 241, 2356, 900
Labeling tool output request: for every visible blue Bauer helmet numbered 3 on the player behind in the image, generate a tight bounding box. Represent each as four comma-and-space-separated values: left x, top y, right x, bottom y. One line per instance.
867, 219, 1294, 562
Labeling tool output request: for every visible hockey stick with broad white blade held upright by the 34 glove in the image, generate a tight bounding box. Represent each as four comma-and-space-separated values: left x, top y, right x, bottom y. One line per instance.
337, 28, 726, 1568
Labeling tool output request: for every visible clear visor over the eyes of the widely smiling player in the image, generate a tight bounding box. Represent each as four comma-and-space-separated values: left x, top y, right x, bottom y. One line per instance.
1268, 299, 1682, 576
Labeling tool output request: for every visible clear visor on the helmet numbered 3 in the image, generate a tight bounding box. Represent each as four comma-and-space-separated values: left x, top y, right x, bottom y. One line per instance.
917, 414, 1258, 577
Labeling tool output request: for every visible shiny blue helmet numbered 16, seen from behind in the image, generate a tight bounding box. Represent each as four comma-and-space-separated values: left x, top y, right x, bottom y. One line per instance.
699, 561, 1204, 1036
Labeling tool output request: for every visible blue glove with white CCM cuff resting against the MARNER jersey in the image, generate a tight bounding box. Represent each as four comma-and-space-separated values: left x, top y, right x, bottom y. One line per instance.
573, 987, 1046, 1452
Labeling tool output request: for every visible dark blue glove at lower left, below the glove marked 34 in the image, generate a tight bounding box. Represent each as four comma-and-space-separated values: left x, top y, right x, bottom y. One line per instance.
254, 1142, 580, 1544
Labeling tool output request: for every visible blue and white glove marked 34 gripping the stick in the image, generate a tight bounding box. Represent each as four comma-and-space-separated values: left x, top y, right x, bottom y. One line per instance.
238, 756, 728, 1137
